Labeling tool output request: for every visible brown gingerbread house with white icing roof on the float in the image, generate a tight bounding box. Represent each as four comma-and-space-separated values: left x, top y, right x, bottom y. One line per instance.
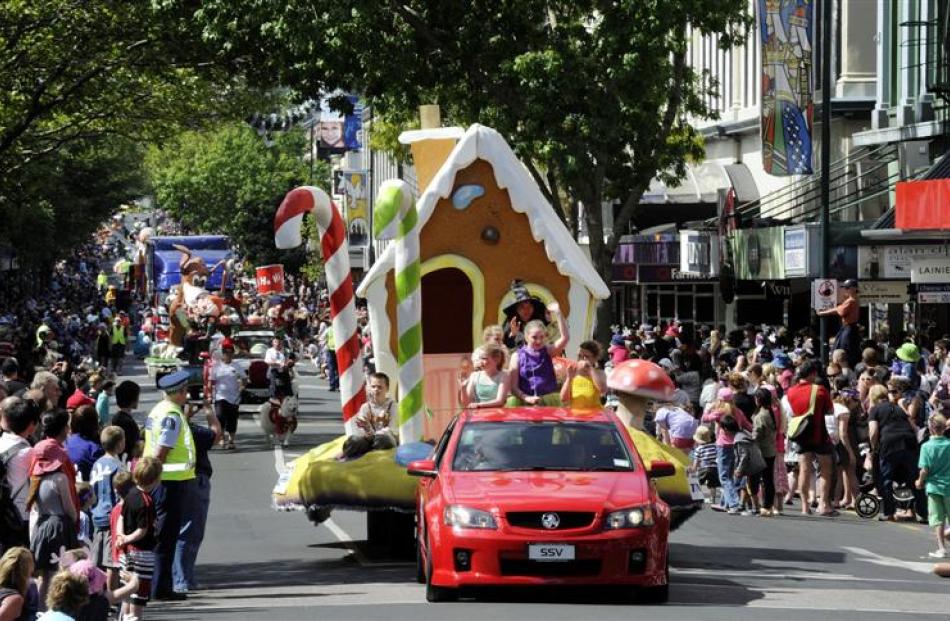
357, 124, 610, 438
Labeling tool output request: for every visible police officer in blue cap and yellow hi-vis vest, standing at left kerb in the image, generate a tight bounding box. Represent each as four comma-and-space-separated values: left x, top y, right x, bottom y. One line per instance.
145, 371, 196, 600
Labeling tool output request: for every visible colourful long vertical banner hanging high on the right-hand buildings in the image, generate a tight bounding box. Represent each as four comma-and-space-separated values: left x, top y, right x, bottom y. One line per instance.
756, 0, 815, 176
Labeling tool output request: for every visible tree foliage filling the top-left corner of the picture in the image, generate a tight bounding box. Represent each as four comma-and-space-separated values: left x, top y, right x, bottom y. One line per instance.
0, 0, 268, 264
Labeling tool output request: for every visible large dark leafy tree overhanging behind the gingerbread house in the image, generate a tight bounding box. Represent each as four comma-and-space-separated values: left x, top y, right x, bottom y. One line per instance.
163, 0, 748, 330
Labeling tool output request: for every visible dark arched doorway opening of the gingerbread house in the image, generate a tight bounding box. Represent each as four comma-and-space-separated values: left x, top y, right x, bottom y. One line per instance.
422, 267, 474, 354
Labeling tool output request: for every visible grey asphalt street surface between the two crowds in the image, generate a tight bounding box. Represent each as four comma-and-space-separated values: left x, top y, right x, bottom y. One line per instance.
115, 356, 950, 621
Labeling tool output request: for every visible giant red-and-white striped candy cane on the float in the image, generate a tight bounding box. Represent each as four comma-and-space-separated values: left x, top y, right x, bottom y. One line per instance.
274, 186, 366, 434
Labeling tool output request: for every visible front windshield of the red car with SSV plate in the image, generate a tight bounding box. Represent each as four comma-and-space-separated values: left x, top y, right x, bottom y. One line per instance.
452, 421, 633, 472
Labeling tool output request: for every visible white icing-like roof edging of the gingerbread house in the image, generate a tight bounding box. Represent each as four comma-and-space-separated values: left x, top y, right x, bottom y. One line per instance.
357, 123, 610, 299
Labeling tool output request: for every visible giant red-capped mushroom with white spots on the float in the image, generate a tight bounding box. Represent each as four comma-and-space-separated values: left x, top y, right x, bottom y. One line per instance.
607, 359, 676, 431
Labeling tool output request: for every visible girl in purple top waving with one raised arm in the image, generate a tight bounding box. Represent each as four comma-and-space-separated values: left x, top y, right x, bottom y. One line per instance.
508, 302, 570, 406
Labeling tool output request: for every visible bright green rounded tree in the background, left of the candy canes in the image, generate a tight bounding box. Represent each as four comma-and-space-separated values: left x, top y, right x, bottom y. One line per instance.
146, 124, 330, 271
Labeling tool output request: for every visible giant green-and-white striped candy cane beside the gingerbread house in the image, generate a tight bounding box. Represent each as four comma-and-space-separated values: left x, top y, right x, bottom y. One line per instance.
373, 179, 424, 444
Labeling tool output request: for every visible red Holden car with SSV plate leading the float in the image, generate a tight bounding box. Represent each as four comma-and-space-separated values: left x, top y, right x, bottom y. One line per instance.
408, 408, 674, 603
